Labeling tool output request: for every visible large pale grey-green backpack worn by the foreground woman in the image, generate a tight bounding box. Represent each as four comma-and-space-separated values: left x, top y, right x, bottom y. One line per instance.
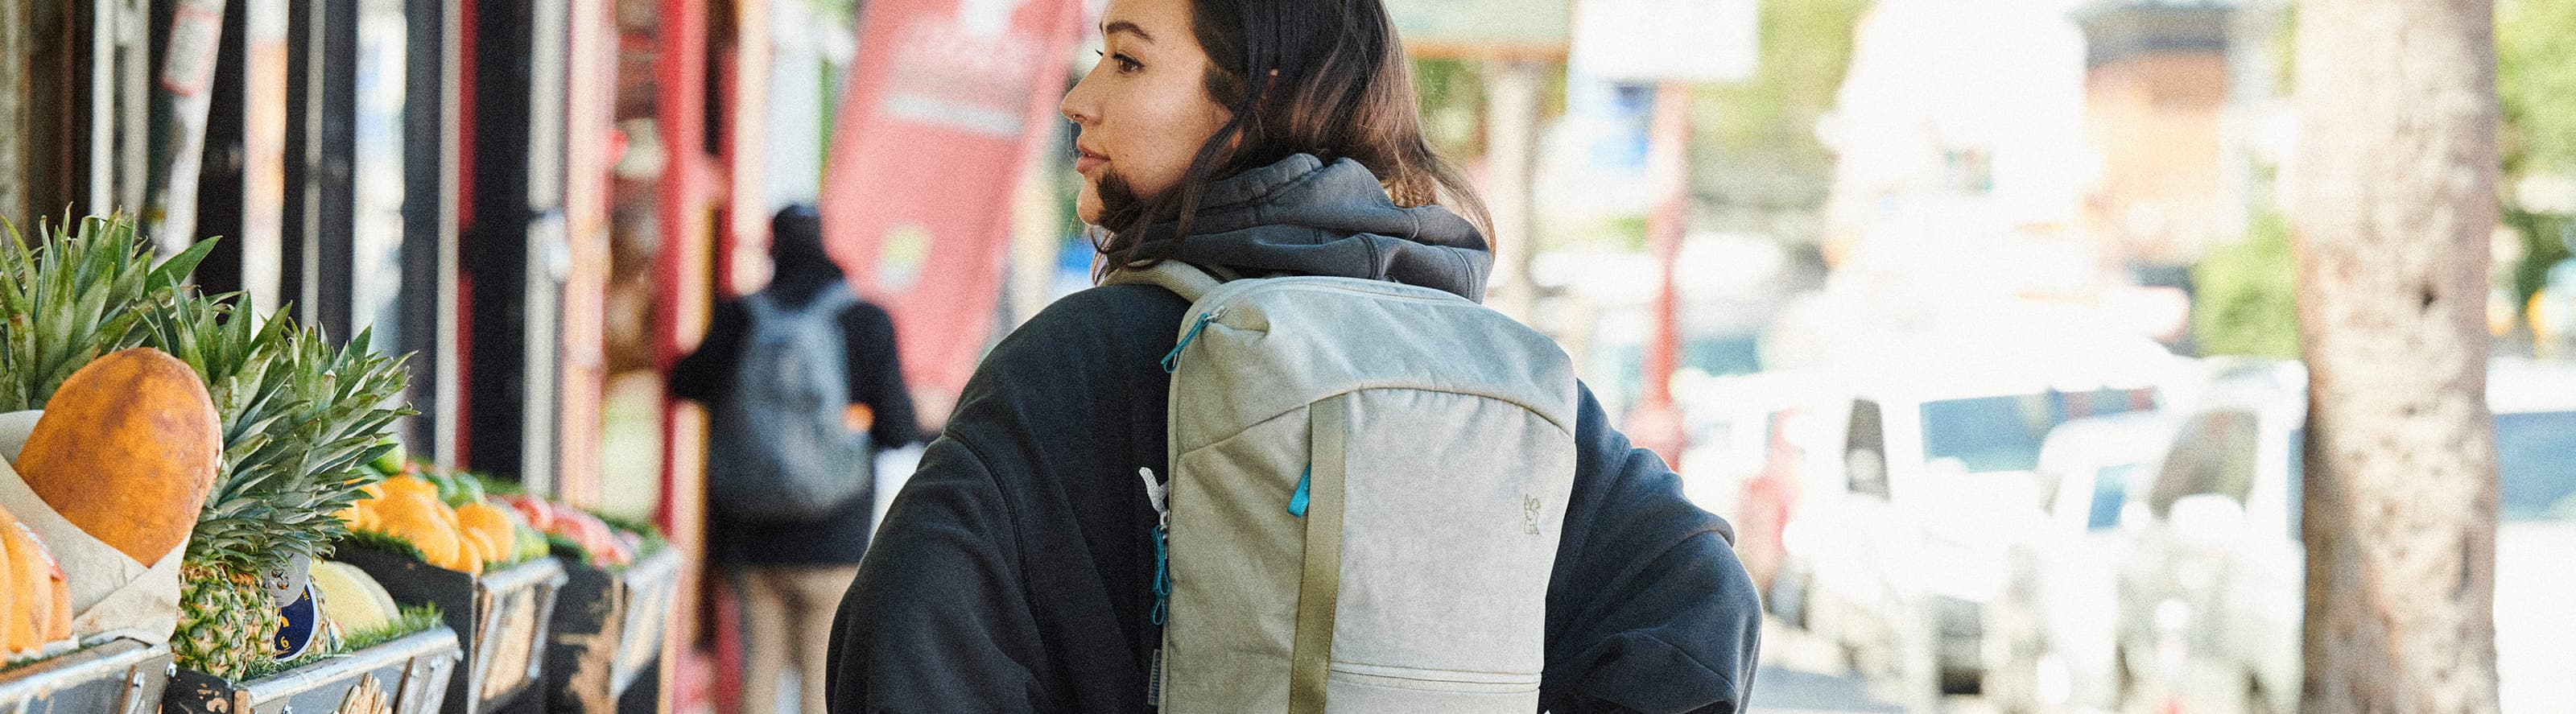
1108, 260, 1576, 714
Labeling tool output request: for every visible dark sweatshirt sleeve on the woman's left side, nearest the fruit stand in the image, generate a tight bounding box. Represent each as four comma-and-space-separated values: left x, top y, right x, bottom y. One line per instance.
824, 438, 1056, 714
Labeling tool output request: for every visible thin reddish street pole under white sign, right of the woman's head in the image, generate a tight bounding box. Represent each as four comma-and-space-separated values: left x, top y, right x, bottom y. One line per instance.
1628, 80, 1690, 464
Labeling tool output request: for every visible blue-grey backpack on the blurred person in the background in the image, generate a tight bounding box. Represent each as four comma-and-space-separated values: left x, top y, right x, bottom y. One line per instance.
706, 283, 876, 523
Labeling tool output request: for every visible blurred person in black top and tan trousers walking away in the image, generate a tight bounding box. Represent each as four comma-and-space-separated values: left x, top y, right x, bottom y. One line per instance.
670, 206, 919, 714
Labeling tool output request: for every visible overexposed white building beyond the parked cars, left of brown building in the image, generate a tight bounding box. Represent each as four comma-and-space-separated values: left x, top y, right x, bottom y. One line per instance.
1765, 0, 2115, 366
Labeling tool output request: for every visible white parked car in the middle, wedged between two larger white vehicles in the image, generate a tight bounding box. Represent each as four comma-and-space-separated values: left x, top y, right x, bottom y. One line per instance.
1984, 410, 2174, 712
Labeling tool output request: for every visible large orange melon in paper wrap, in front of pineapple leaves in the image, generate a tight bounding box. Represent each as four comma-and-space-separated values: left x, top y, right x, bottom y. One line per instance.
15, 348, 224, 564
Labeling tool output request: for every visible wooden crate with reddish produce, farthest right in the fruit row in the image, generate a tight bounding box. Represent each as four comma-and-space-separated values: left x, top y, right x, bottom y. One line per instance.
546, 547, 680, 714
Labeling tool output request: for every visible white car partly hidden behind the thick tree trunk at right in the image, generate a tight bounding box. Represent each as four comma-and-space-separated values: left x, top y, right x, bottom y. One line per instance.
2117, 361, 2576, 714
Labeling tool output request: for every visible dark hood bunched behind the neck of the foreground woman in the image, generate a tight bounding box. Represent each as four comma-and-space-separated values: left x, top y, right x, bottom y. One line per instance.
1164, 155, 1494, 302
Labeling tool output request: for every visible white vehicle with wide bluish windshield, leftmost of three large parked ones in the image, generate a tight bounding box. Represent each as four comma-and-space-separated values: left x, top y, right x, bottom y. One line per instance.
1775, 369, 2159, 709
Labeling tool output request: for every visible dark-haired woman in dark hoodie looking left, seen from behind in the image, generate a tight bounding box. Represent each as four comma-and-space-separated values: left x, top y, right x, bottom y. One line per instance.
829, 0, 1762, 714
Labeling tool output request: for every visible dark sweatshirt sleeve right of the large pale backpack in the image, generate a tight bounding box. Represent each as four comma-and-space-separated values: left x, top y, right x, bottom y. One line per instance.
1541, 390, 1762, 714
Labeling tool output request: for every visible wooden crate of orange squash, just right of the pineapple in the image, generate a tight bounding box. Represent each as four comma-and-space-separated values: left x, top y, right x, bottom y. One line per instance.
332, 544, 567, 714
